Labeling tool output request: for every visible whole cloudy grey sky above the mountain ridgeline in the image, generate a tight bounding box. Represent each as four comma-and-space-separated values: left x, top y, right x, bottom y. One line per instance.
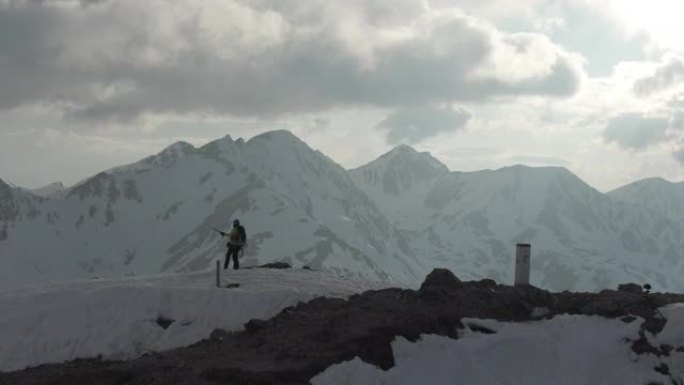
0, 0, 684, 191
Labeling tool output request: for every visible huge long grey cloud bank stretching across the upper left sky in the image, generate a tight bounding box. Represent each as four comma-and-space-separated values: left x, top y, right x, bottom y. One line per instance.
0, 0, 582, 121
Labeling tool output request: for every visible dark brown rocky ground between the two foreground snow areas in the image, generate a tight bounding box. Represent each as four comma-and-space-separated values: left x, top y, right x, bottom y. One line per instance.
0, 270, 684, 385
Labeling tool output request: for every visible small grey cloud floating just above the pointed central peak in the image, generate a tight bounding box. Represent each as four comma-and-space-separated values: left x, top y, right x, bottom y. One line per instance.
378, 107, 471, 144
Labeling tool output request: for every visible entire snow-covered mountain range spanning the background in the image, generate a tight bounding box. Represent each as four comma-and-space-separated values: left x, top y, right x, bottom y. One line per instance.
0, 131, 684, 292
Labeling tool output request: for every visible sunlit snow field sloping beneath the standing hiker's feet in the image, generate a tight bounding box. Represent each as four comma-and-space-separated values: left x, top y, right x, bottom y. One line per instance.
0, 269, 390, 371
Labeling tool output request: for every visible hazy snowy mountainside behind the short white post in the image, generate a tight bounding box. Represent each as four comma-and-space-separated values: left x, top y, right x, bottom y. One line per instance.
351, 152, 684, 290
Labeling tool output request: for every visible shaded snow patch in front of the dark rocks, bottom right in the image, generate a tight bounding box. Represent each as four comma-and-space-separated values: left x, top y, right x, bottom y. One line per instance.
312, 312, 684, 385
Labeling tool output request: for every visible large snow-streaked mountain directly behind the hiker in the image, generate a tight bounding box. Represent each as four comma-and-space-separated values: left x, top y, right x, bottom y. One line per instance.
0, 131, 424, 283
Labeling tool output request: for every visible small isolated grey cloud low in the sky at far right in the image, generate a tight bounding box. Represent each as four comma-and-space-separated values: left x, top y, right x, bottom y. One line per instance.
603, 113, 670, 150
